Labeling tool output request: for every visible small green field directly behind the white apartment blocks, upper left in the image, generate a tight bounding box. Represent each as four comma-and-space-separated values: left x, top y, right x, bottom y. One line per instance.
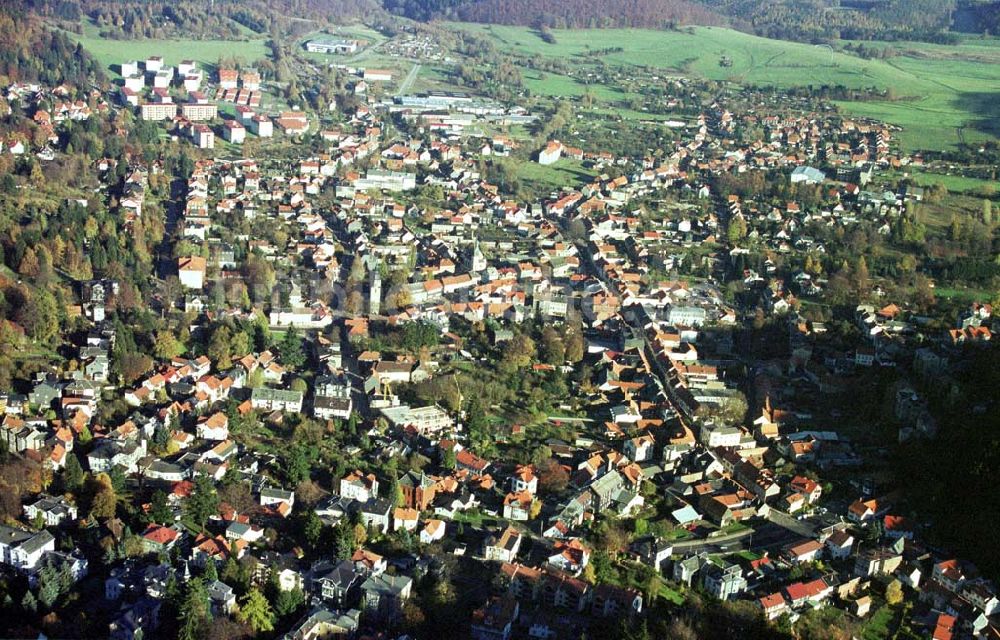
65, 24, 270, 75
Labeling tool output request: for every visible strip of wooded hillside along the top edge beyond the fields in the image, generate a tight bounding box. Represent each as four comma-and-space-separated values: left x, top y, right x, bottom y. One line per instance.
19, 0, 1000, 43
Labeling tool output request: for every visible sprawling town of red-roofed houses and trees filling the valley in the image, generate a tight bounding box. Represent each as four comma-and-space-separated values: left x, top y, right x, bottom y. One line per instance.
0, 3, 1000, 640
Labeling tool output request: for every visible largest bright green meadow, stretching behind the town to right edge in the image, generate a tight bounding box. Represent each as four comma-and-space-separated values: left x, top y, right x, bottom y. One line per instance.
453, 24, 1000, 149
